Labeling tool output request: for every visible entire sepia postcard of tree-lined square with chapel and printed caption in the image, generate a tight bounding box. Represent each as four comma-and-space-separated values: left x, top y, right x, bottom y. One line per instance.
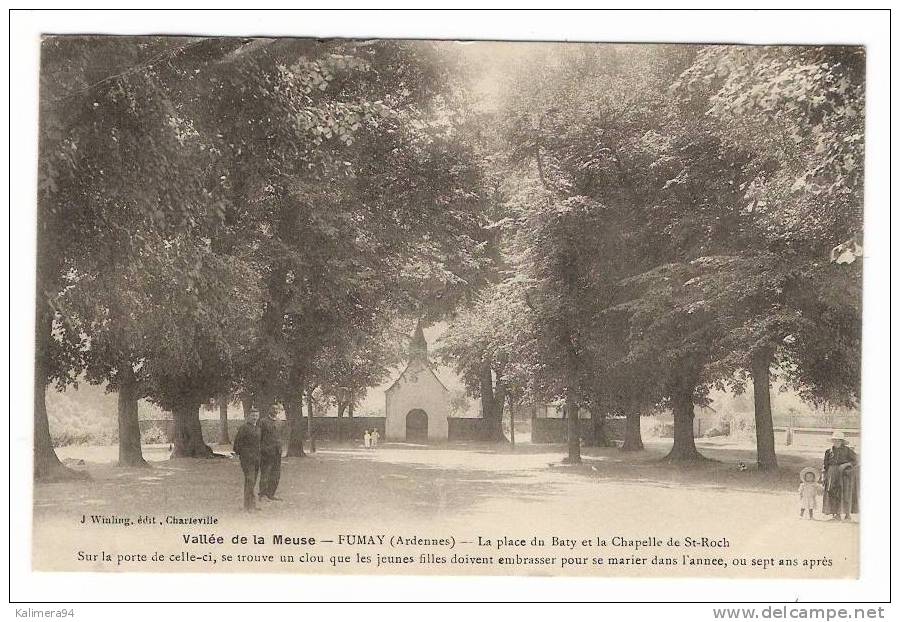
12, 9, 887, 608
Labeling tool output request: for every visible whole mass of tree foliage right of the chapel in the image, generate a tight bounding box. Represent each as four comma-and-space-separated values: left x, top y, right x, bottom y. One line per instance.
452, 45, 864, 468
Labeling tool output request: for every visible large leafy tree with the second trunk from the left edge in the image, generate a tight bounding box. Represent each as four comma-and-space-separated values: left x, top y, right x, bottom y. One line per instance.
38, 37, 268, 464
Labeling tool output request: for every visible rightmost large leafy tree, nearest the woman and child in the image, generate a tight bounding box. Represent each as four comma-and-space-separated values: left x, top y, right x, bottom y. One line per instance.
673, 46, 865, 469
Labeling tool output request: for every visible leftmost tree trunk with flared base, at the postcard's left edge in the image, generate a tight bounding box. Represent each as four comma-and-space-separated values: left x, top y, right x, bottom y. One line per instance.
32, 296, 82, 482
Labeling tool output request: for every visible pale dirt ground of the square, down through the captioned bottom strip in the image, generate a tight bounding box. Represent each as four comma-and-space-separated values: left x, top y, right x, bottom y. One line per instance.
33, 440, 859, 578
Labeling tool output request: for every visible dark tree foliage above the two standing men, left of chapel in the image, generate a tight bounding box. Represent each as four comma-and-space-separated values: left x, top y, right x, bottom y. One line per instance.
198, 40, 496, 428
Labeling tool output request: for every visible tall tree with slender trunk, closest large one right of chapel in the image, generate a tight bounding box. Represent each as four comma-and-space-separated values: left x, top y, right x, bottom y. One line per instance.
496, 46, 727, 461
